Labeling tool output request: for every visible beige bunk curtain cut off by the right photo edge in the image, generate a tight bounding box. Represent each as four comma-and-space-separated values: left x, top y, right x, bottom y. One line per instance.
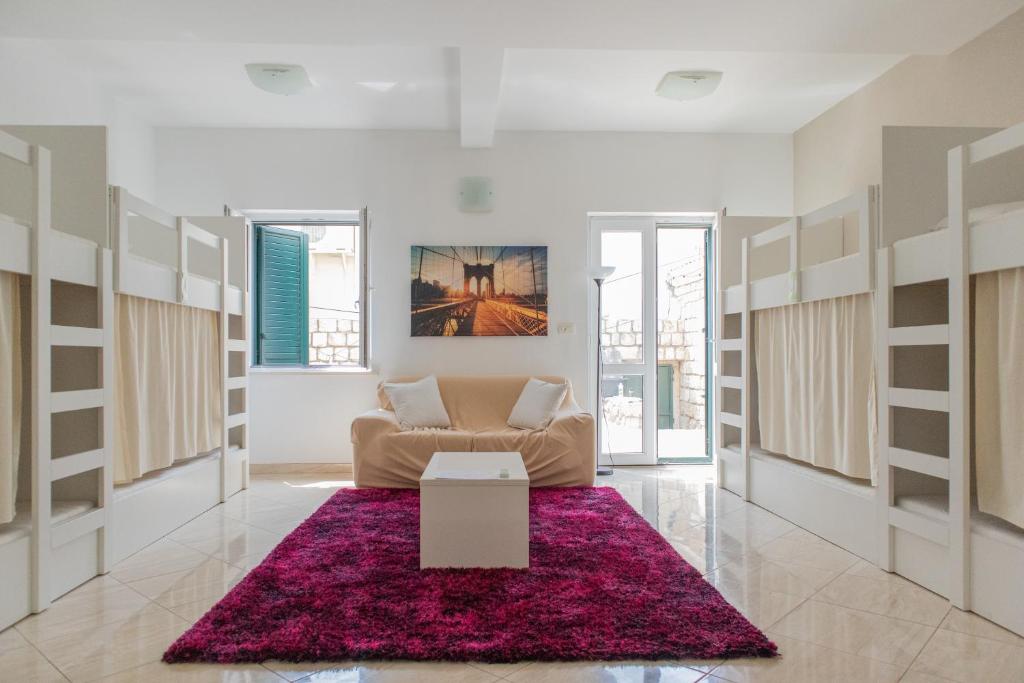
974, 268, 1024, 527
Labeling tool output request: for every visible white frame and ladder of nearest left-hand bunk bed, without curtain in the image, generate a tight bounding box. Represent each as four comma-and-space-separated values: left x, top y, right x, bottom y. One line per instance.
0, 131, 114, 629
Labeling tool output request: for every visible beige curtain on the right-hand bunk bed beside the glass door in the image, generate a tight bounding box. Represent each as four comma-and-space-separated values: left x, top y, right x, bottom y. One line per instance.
754, 294, 878, 483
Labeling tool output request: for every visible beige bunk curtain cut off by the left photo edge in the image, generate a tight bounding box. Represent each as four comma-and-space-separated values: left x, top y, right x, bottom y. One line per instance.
0, 272, 22, 524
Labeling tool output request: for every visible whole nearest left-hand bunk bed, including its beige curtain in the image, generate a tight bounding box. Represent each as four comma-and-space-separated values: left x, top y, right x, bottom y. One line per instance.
0, 131, 114, 629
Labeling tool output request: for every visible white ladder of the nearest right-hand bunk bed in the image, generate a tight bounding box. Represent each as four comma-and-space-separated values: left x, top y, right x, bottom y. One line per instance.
876, 153, 971, 609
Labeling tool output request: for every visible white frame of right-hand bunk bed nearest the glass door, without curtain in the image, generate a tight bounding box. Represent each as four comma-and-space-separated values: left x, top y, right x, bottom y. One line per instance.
714, 186, 879, 561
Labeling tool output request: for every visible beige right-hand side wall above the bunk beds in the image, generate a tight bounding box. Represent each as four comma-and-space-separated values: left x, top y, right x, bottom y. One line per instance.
794, 10, 1024, 214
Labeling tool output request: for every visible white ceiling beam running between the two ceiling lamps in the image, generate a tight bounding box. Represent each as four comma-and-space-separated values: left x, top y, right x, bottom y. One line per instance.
459, 47, 505, 147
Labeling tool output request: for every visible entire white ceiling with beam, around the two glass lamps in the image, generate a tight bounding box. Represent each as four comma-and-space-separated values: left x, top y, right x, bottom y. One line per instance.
0, 0, 1024, 137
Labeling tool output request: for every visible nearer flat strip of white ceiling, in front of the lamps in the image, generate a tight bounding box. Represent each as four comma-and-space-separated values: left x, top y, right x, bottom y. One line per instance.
0, 0, 1024, 54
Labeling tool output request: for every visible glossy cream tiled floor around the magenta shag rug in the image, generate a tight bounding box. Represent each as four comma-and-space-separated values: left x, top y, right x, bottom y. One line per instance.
0, 467, 1024, 683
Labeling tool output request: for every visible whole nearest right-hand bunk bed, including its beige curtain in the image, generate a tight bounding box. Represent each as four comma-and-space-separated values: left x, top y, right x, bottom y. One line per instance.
878, 124, 1024, 635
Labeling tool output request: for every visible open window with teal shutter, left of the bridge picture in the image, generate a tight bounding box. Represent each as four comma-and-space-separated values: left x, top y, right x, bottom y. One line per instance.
253, 211, 369, 368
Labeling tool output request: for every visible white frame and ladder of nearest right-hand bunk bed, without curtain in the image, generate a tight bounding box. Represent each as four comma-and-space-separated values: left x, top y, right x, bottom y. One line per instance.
877, 124, 1024, 634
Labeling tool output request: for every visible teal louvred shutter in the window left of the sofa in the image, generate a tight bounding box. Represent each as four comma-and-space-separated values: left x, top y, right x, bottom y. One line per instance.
254, 225, 309, 366
